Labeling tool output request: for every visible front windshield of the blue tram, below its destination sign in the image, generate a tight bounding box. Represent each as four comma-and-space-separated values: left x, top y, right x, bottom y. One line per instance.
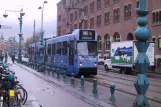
77, 42, 97, 56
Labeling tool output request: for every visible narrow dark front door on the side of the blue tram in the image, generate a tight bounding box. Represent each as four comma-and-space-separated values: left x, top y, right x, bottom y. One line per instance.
69, 40, 74, 69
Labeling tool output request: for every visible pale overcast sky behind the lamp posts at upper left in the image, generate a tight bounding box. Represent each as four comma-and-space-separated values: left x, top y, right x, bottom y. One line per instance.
0, 0, 60, 40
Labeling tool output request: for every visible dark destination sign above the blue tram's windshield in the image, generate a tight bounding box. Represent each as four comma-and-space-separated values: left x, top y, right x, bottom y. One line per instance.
79, 30, 95, 40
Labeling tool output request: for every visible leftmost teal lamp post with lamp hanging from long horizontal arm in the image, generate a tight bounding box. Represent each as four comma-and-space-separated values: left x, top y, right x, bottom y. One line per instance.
3, 8, 25, 63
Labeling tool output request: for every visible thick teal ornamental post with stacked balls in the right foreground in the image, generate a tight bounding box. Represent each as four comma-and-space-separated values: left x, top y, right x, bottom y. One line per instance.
133, 0, 150, 107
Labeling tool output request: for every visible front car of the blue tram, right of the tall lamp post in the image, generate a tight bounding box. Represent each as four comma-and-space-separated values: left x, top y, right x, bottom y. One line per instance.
46, 29, 98, 75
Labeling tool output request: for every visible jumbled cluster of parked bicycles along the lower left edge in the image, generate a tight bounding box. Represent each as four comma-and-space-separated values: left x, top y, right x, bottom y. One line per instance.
0, 62, 28, 107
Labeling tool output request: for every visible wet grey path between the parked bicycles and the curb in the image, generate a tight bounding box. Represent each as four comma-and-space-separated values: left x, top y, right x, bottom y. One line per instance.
10, 64, 97, 107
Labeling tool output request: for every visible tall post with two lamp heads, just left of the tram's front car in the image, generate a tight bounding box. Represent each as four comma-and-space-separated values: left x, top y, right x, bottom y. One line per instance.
38, 1, 47, 64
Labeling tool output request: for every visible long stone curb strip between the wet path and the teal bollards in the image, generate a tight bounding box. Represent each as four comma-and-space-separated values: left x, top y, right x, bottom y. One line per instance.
16, 64, 114, 107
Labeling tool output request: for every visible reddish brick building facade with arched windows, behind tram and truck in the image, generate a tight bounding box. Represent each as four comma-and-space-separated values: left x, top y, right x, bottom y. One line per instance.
57, 0, 161, 67
